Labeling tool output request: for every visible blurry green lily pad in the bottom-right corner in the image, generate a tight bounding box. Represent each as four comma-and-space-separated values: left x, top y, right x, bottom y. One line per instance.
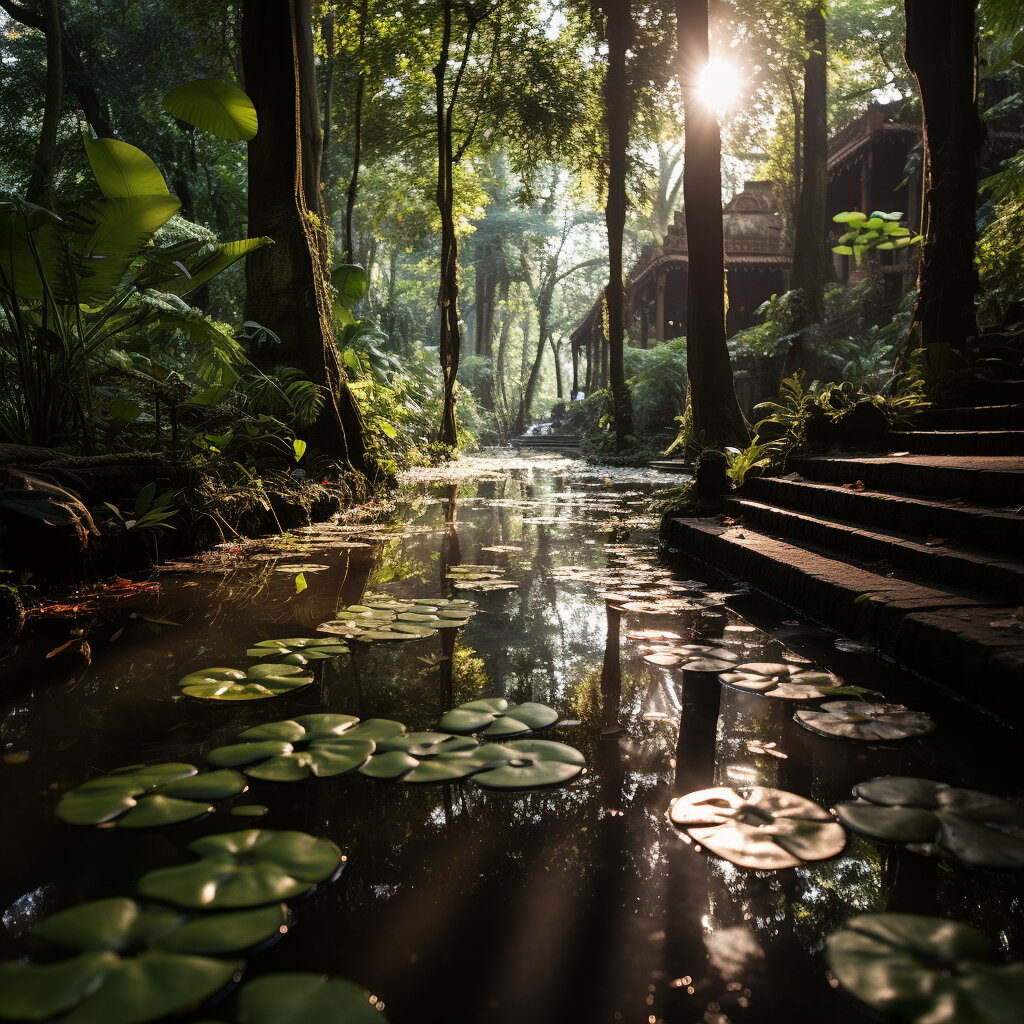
826, 913, 1024, 1024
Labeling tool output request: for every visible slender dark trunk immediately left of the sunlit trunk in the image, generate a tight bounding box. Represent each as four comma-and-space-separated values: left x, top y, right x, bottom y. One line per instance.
604, 0, 633, 452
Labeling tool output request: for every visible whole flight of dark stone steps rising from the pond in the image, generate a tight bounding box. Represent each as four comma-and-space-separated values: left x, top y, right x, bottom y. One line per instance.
663, 391, 1024, 721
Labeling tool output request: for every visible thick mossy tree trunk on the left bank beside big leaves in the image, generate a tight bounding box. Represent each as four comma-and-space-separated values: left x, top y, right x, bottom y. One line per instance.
241, 0, 370, 472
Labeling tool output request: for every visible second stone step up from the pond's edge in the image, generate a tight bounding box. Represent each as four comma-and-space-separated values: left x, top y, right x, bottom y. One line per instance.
726, 498, 1024, 604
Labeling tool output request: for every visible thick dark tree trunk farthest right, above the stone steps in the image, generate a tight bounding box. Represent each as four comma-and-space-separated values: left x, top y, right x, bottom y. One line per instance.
909, 0, 981, 348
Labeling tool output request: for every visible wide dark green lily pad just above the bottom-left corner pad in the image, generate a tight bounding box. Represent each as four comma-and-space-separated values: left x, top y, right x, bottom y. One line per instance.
32, 897, 288, 955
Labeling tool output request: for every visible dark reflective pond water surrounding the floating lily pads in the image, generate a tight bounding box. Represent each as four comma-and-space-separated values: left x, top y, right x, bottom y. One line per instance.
0, 456, 1024, 1024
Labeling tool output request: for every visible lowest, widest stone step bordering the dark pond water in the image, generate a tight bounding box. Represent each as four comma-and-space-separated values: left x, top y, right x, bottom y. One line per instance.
662, 518, 1024, 719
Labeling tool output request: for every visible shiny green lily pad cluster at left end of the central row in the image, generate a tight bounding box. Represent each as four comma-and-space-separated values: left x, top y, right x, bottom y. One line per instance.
208, 715, 374, 782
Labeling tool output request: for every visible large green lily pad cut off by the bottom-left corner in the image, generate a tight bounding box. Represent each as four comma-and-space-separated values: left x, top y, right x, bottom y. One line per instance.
0, 950, 239, 1024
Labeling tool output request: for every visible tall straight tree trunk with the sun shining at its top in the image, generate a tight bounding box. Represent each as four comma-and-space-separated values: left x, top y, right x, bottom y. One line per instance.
676, 0, 750, 449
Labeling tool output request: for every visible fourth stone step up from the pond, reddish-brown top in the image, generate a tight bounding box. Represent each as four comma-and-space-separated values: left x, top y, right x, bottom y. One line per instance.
788, 449, 1024, 509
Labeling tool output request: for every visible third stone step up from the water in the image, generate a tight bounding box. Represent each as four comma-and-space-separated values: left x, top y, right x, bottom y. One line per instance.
741, 476, 1024, 552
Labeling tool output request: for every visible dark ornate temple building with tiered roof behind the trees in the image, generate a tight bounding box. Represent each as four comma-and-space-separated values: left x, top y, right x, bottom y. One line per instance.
570, 103, 922, 394
